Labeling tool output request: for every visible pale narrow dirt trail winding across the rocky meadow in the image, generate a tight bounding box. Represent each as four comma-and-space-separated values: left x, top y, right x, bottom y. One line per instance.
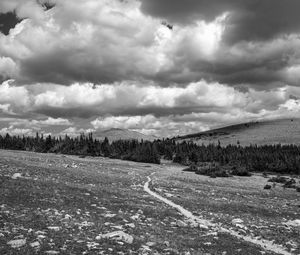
144, 173, 293, 255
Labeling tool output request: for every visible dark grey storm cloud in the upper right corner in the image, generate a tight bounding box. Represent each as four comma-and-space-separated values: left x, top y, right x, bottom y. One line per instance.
141, 0, 300, 42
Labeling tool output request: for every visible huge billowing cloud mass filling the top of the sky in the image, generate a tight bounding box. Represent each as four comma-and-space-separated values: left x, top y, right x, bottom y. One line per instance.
0, 0, 300, 87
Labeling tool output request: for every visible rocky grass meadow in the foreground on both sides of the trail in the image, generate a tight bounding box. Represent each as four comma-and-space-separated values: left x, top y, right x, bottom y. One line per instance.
0, 150, 300, 255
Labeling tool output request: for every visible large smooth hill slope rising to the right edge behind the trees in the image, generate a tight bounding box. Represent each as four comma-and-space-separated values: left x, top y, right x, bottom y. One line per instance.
176, 119, 300, 146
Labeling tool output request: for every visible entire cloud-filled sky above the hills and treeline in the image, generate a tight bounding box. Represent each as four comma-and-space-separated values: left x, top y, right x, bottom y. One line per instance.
0, 0, 300, 137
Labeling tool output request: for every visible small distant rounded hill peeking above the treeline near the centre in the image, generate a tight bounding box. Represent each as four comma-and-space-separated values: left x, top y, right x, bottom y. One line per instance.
93, 128, 157, 141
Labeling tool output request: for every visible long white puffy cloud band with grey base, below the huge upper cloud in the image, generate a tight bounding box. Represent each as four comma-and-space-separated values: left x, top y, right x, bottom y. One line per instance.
32, 81, 248, 118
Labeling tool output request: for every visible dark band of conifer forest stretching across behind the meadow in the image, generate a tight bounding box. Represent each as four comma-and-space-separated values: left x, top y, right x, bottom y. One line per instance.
0, 133, 300, 175
